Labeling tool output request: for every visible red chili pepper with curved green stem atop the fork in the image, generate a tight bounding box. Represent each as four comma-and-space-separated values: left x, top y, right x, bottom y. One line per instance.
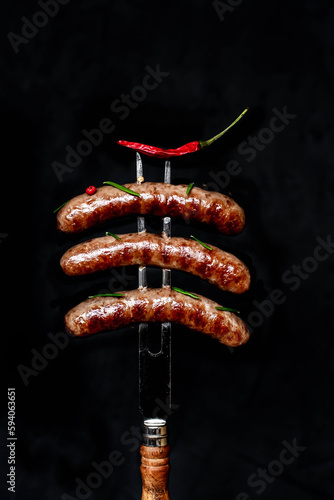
117, 108, 248, 158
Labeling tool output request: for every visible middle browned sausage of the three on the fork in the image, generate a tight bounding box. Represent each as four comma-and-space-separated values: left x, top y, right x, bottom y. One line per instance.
60, 233, 250, 293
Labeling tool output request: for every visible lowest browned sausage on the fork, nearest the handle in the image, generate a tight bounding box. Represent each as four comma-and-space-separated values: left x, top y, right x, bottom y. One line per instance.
65, 288, 249, 347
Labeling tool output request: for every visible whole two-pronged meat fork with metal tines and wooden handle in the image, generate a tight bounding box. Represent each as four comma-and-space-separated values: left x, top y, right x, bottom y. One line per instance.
136, 153, 171, 500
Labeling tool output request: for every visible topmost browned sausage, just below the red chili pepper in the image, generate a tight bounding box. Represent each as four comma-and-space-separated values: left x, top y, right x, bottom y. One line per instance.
57, 182, 245, 235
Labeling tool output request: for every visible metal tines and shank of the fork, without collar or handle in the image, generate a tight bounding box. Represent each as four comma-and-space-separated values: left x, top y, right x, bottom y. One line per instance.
136, 153, 171, 419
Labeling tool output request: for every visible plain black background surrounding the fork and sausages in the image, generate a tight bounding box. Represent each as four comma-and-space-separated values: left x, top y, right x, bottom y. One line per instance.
0, 0, 334, 500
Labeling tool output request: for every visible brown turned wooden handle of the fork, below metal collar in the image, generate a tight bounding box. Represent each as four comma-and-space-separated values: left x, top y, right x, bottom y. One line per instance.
140, 445, 170, 500
